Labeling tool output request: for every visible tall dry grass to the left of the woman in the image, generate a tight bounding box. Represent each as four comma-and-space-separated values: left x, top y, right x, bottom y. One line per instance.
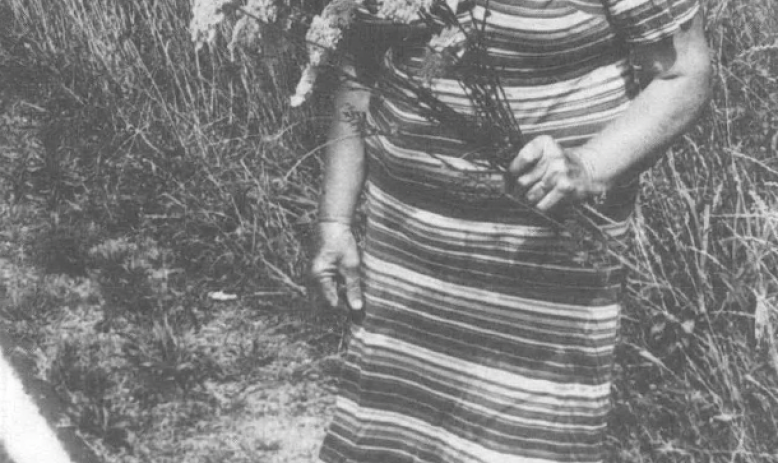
1, 0, 318, 289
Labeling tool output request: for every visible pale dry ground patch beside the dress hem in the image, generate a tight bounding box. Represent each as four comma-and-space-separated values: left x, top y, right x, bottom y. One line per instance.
133, 320, 334, 463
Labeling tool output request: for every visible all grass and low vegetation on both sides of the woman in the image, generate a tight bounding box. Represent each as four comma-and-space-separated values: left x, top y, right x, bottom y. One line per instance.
0, 0, 778, 463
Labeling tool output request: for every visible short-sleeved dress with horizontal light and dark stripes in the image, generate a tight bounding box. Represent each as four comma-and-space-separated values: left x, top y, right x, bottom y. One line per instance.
320, 0, 699, 463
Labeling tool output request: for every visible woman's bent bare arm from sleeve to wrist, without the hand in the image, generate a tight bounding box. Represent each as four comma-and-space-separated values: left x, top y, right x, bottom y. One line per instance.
578, 12, 711, 189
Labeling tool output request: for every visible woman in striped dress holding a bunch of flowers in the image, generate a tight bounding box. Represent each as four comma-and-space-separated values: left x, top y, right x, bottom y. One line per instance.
312, 0, 710, 463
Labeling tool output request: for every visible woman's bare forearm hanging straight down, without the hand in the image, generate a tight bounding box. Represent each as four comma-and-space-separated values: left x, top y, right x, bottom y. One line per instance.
319, 73, 369, 223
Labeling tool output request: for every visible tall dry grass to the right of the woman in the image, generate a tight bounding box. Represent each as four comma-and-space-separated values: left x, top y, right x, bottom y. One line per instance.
611, 0, 778, 462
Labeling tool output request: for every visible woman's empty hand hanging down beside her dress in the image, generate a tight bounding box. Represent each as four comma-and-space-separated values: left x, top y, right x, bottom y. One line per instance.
311, 222, 364, 316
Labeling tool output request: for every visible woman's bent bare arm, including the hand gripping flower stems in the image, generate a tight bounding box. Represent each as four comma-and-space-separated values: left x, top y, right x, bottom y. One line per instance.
510, 14, 711, 210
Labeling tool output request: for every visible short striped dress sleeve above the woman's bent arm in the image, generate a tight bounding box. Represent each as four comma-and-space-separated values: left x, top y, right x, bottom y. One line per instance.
602, 0, 700, 44
